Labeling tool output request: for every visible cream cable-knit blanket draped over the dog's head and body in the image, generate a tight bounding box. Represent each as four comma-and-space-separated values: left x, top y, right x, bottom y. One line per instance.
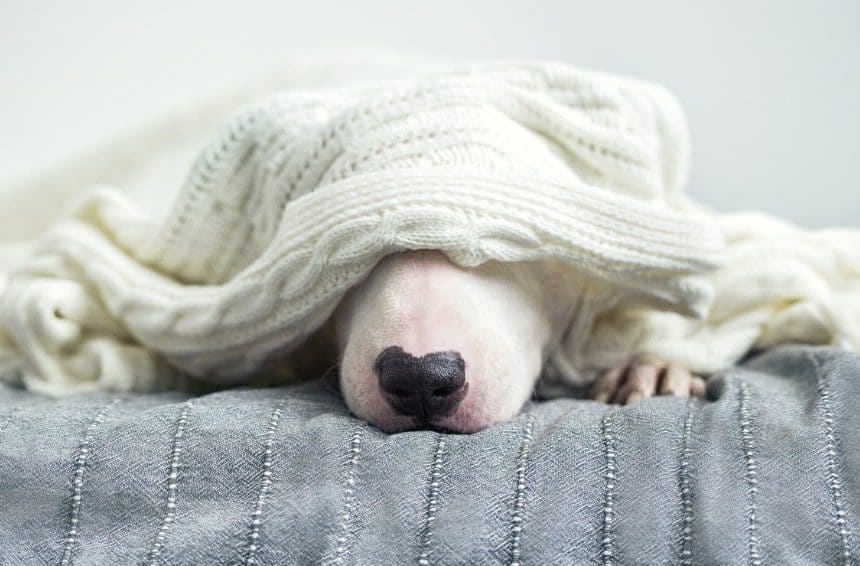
0, 56, 860, 394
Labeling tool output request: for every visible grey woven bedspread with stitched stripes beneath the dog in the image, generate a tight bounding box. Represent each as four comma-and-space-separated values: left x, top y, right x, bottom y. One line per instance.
0, 347, 860, 565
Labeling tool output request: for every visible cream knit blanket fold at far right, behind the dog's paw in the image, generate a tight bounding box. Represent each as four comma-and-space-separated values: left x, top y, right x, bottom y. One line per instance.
580, 213, 860, 380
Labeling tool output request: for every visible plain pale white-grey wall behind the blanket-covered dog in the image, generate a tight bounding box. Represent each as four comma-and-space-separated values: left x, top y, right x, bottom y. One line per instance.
0, 0, 860, 230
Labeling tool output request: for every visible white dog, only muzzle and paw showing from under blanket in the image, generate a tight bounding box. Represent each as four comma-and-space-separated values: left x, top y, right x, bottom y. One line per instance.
308, 250, 705, 433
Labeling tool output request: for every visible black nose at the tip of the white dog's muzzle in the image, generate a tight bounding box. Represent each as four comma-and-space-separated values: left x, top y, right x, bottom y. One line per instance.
373, 346, 469, 423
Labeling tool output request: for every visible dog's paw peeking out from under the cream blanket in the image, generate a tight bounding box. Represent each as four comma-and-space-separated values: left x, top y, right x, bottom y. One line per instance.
590, 356, 705, 405
